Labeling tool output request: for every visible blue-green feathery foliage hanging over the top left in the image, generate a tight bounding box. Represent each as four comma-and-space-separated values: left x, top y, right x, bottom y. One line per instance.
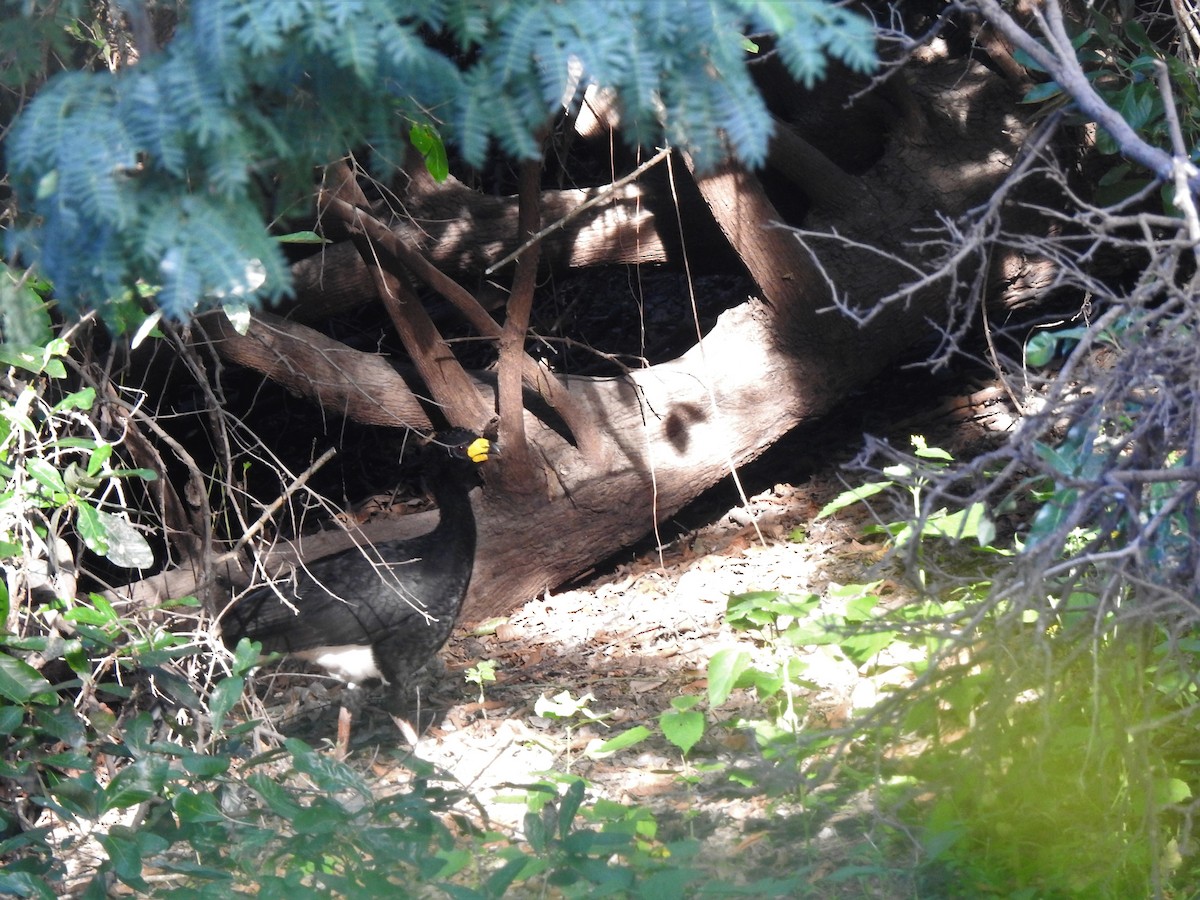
7, 0, 875, 318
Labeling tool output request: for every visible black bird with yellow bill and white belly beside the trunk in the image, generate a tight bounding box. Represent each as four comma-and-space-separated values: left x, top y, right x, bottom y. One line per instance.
221, 428, 492, 684
